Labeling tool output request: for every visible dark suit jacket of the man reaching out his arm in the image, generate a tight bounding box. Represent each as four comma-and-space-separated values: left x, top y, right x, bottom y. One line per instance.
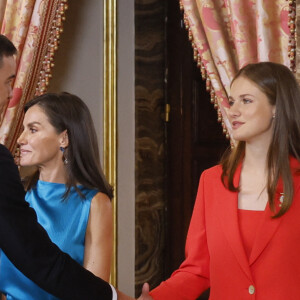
0, 145, 112, 300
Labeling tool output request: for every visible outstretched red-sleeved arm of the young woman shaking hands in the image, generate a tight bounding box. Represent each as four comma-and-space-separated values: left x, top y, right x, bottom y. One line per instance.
149, 171, 210, 300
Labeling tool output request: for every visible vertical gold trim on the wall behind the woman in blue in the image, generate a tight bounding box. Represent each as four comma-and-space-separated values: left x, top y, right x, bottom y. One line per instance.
103, 0, 117, 286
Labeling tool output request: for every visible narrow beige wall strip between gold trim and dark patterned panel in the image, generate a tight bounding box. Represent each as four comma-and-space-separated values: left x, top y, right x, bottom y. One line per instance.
117, 0, 135, 296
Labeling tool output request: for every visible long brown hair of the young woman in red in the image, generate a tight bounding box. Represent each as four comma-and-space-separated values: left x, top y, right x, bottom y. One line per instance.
221, 62, 300, 217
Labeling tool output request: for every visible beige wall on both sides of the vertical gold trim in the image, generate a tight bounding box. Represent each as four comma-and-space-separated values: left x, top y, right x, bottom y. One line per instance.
49, 0, 135, 296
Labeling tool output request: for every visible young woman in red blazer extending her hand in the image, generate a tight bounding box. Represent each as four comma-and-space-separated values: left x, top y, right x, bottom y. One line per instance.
139, 62, 300, 300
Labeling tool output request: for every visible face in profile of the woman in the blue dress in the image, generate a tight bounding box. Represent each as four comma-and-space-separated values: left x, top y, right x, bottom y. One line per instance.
18, 105, 66, 167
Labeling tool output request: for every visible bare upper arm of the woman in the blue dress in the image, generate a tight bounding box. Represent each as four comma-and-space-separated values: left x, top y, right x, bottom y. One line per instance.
83, 193, 113, 281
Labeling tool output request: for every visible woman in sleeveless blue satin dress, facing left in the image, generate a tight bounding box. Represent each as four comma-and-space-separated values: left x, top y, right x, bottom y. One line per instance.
0, 93, 113, 300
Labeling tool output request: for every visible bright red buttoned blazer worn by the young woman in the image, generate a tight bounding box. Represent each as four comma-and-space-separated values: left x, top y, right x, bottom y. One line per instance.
150, 159, 300, 300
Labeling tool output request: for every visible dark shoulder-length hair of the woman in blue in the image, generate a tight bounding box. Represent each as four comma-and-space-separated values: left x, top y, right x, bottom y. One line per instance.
24, 92, 113, 199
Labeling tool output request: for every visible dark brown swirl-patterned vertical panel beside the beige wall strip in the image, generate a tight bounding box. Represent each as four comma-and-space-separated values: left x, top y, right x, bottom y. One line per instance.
135, 0, 165, 295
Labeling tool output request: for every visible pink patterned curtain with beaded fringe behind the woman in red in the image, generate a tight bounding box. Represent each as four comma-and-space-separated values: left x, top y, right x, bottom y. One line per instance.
180, 0, 295, 137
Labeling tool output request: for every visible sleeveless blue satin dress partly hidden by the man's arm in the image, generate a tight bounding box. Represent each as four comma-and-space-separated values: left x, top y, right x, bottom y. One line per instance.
0, 180, 97, 300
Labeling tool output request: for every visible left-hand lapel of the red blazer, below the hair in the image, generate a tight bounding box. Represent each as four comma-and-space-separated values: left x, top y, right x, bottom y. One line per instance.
218, 164, 252, 280
